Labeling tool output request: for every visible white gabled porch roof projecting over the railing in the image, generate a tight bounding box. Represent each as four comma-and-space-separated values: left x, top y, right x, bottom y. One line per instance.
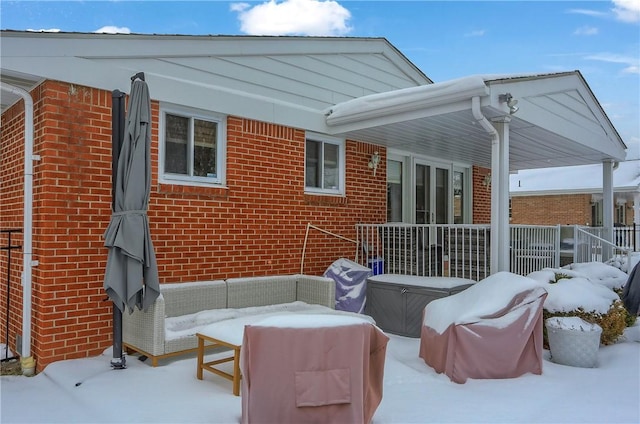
325, 71, 626, 171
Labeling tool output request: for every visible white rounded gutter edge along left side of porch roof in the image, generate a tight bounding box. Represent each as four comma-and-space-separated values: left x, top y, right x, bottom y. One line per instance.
326, 76, 489, 131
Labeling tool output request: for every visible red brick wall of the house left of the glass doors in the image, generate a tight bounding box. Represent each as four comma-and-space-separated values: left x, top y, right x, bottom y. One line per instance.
0, 81, 386, 370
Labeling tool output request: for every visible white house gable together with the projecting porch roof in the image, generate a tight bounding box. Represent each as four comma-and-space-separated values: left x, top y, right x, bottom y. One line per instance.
0, 31, 626, 171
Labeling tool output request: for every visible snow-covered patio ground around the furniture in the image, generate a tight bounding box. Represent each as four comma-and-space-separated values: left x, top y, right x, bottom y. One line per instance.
0, 324, 640, 424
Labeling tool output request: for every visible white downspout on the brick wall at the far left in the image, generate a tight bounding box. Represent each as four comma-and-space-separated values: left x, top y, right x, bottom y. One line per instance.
0, 84, 37, 368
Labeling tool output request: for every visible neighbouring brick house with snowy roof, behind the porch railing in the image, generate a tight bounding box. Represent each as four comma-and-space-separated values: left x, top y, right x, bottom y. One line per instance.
510, 159, 640, 227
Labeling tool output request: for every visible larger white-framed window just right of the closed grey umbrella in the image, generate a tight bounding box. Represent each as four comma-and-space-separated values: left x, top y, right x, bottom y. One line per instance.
160, 103, 226, 184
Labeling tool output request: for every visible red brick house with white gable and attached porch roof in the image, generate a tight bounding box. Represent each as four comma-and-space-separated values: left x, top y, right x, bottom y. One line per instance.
0, 31, 626, 369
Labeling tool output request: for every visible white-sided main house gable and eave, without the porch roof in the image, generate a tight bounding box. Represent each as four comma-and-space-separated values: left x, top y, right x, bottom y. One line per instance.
0, 30, 432, 132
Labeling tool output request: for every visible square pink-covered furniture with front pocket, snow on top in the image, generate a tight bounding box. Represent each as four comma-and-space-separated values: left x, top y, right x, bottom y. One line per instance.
240, 314, 389, 424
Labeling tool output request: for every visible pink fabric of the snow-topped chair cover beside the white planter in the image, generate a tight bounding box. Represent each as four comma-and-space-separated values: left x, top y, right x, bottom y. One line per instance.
420, 288, 547, 383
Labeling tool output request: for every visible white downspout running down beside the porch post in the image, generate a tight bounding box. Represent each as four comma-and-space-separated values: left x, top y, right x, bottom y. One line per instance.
471, 96, 501, 274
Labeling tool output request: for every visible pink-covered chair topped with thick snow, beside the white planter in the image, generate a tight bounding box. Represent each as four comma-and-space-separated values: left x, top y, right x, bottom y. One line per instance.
419, 272, 547, 383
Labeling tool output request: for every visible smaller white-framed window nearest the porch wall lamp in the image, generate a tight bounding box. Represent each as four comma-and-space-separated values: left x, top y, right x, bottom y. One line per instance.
304, 134, 344, 194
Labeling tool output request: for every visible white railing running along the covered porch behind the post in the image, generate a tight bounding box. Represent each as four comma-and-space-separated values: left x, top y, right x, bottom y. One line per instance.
356, 223, 630, 281
